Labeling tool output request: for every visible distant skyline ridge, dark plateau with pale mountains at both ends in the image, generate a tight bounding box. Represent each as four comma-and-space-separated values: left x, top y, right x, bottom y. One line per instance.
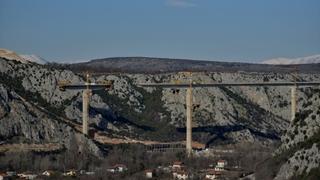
0, 49, 320, 73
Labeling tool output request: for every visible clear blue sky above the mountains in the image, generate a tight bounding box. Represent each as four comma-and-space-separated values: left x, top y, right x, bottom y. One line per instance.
0, 0, 320, 62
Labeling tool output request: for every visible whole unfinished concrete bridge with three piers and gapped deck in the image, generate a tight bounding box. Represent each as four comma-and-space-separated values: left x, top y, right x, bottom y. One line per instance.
58, 73, 320, 157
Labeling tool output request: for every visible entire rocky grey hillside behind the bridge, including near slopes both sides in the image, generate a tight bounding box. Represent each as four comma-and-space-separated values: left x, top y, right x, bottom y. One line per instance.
0, 55, 320, 176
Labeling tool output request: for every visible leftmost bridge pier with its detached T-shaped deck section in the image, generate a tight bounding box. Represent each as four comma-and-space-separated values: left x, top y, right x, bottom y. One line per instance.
58, 73, 113, 135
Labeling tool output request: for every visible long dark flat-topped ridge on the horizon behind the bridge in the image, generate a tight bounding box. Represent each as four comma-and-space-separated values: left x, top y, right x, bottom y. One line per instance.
62, 57, 320, 73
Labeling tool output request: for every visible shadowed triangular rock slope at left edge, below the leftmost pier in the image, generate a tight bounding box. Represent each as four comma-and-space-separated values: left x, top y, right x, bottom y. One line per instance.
0, 84, 102, 157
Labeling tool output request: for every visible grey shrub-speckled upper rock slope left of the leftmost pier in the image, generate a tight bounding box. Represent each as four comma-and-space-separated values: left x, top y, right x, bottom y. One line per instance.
0, 59, 83, 105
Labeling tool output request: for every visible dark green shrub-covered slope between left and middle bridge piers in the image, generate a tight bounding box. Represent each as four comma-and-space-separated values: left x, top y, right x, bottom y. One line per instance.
96, 82, 184, 141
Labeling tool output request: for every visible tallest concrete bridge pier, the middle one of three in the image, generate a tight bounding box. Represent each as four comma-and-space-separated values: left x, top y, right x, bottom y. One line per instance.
186, 87, 192, 157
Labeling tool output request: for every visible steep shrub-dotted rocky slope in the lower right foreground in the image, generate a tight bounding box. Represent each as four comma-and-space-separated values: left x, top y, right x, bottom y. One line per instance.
275, 89, 320, 180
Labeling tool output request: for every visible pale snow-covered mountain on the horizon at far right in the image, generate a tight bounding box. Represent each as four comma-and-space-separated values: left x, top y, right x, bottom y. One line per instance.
262, 54, 320, 65
